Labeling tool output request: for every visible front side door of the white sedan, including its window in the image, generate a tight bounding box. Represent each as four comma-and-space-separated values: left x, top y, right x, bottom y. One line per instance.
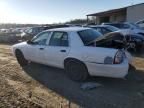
27, 31, 51, 63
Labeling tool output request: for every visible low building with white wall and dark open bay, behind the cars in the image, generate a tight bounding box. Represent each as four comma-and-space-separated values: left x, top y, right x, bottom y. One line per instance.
87, 3, 144, 24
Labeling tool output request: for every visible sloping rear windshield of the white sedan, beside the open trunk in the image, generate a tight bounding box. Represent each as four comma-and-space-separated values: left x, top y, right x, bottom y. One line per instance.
78, 29, 102, 45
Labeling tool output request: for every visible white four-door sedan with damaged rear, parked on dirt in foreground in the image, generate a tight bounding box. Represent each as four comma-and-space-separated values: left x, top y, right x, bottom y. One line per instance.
12, 27, 129, 81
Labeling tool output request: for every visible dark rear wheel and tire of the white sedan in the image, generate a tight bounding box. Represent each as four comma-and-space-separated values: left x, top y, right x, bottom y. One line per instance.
65, 60, 89, 81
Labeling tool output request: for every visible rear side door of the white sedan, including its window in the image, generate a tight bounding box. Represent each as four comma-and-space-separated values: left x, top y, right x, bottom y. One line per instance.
45, 31, 70, 68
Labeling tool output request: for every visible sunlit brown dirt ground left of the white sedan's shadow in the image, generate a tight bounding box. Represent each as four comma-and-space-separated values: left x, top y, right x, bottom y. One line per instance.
0, 45, 78, 108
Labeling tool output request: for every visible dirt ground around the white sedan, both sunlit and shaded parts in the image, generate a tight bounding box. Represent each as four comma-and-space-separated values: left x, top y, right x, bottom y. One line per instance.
0, 44, 144, 108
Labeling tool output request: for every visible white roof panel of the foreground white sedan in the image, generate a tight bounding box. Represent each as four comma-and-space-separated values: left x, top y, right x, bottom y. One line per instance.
46, 27, 90, 32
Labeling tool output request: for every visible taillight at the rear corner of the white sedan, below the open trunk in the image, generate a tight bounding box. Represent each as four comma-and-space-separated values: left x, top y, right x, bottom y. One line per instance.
113, 50, 124, 64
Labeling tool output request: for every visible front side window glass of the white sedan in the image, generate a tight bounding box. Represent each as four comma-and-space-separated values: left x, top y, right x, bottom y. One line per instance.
32, 32, 51, 45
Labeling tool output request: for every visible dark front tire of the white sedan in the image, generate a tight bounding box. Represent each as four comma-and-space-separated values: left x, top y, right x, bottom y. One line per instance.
16, 50, 28, 67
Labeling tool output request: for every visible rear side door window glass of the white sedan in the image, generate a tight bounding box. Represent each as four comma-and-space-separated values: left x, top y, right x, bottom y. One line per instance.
49, 32, 68, 47
